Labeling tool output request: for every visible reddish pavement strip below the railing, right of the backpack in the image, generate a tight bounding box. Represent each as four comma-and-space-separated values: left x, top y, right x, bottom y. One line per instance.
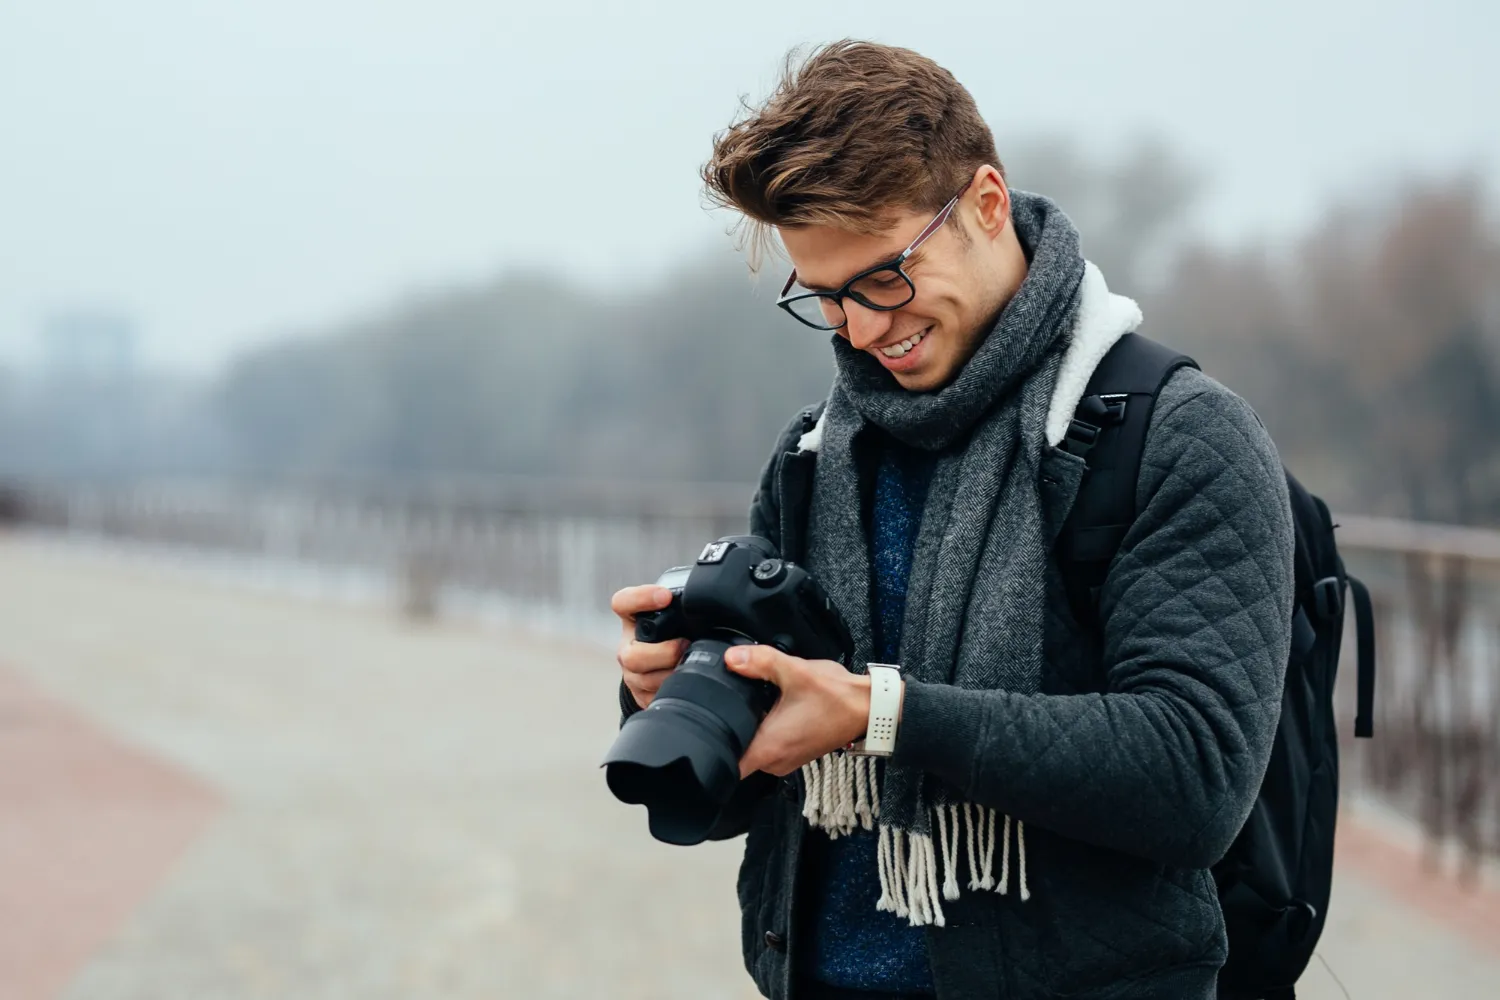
1334, 813, 1500, 955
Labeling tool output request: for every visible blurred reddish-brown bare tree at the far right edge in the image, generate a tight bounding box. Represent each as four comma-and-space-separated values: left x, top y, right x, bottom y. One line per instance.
1298, 180, 1500, 523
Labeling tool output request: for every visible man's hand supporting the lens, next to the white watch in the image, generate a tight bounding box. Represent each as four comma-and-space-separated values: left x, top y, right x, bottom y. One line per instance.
725, 646, 870, 778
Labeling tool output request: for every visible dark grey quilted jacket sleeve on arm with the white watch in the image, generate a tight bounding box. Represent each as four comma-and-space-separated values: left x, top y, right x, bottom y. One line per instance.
894, 369, 1295, 868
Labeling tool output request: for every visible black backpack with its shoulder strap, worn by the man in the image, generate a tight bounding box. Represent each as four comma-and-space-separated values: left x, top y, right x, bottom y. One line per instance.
1058, 334, 1376, 1000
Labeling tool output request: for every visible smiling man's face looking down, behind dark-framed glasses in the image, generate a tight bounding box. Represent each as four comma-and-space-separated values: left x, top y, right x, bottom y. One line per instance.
780, 168, 1026, 393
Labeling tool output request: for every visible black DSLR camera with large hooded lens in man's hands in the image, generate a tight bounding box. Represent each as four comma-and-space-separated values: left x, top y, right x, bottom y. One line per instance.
605, 535, 854, 844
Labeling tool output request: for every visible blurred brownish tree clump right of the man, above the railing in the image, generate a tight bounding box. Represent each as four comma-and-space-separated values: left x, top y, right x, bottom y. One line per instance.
1148, 178, 1500, 525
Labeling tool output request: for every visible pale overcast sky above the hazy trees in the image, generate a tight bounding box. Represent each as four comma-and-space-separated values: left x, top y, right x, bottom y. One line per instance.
0, 0, 1500, 372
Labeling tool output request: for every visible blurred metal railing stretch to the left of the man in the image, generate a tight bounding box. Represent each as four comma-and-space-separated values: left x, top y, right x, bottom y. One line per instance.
0, 478, 752, 615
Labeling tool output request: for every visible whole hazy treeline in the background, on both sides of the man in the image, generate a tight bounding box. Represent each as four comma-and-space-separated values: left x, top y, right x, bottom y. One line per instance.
0, 142, 1500, 525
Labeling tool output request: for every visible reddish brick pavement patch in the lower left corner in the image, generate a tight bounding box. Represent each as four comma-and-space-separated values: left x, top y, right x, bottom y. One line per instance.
0, 669, 218, 1000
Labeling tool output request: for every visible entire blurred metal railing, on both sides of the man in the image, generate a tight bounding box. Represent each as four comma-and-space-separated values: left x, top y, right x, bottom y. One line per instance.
0, 480, 1500, 874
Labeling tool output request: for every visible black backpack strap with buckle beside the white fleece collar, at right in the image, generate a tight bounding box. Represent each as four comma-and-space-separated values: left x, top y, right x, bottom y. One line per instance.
1058, 333, 1199, 622
